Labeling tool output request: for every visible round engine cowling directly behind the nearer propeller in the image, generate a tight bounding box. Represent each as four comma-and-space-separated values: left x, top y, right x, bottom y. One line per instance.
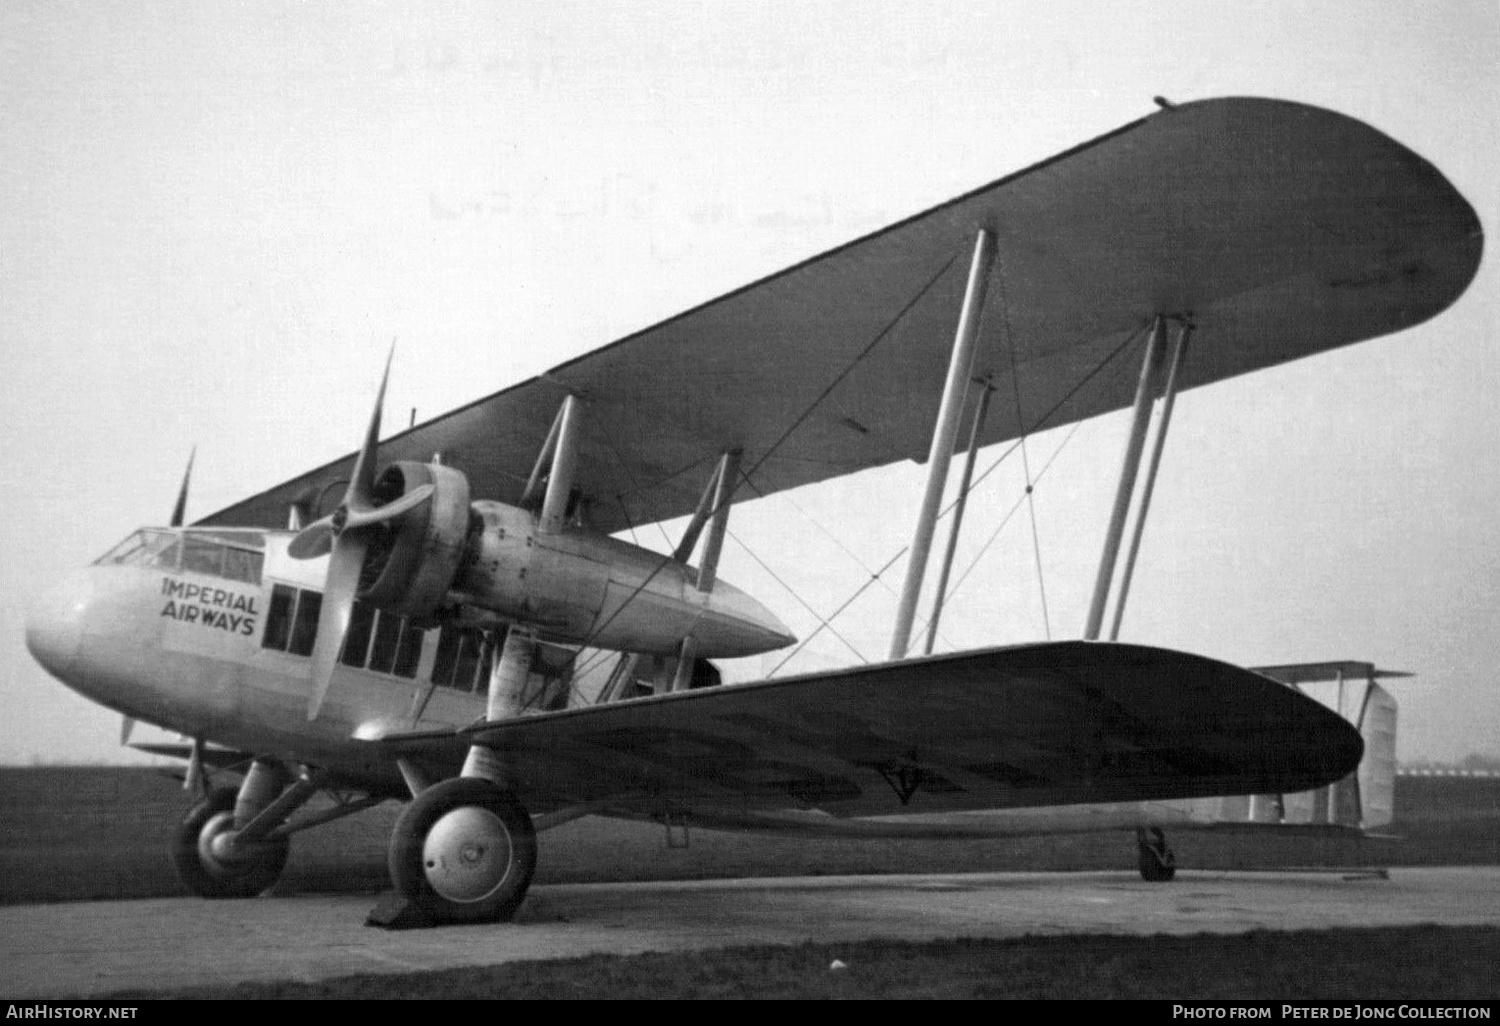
359, 461, 470, 618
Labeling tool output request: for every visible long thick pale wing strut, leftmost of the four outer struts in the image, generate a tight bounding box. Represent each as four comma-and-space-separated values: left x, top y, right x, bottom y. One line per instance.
891, 228, 995, 660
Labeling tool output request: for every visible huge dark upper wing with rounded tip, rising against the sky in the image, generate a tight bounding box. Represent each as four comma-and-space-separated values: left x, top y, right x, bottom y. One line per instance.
203, 99, 1482, 531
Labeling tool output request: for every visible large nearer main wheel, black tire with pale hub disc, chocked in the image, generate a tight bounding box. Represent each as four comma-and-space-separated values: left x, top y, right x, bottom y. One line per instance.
390, 777, 537, 923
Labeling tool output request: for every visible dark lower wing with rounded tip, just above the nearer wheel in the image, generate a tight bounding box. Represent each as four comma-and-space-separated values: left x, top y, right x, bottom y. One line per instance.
375, 642, 1362, 815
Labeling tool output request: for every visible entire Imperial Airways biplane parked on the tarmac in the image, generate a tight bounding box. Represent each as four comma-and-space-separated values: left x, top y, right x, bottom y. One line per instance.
27, 99, 1484, 923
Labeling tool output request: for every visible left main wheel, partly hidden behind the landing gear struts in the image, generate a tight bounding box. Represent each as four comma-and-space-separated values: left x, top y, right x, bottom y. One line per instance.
173, 788, 291, 899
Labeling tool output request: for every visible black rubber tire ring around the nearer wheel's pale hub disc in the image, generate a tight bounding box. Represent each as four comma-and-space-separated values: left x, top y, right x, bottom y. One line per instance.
387, 777, 537, 923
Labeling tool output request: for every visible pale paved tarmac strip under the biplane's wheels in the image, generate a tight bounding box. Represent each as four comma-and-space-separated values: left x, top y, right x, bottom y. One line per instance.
0, 867, 1500, 999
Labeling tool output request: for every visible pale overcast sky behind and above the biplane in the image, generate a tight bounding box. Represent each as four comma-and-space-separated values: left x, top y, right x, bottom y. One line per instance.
0, 0, 1500, 762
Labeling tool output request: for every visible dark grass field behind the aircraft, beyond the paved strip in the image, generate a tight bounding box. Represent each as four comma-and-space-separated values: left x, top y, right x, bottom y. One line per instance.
0, 768, 1500, 905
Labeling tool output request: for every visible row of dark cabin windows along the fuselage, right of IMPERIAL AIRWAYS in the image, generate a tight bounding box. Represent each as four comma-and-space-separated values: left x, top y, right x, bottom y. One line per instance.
261, 585, 494, 692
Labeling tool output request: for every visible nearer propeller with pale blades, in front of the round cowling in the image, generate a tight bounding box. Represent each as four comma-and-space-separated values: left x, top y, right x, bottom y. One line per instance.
287, 342, 434, 720
